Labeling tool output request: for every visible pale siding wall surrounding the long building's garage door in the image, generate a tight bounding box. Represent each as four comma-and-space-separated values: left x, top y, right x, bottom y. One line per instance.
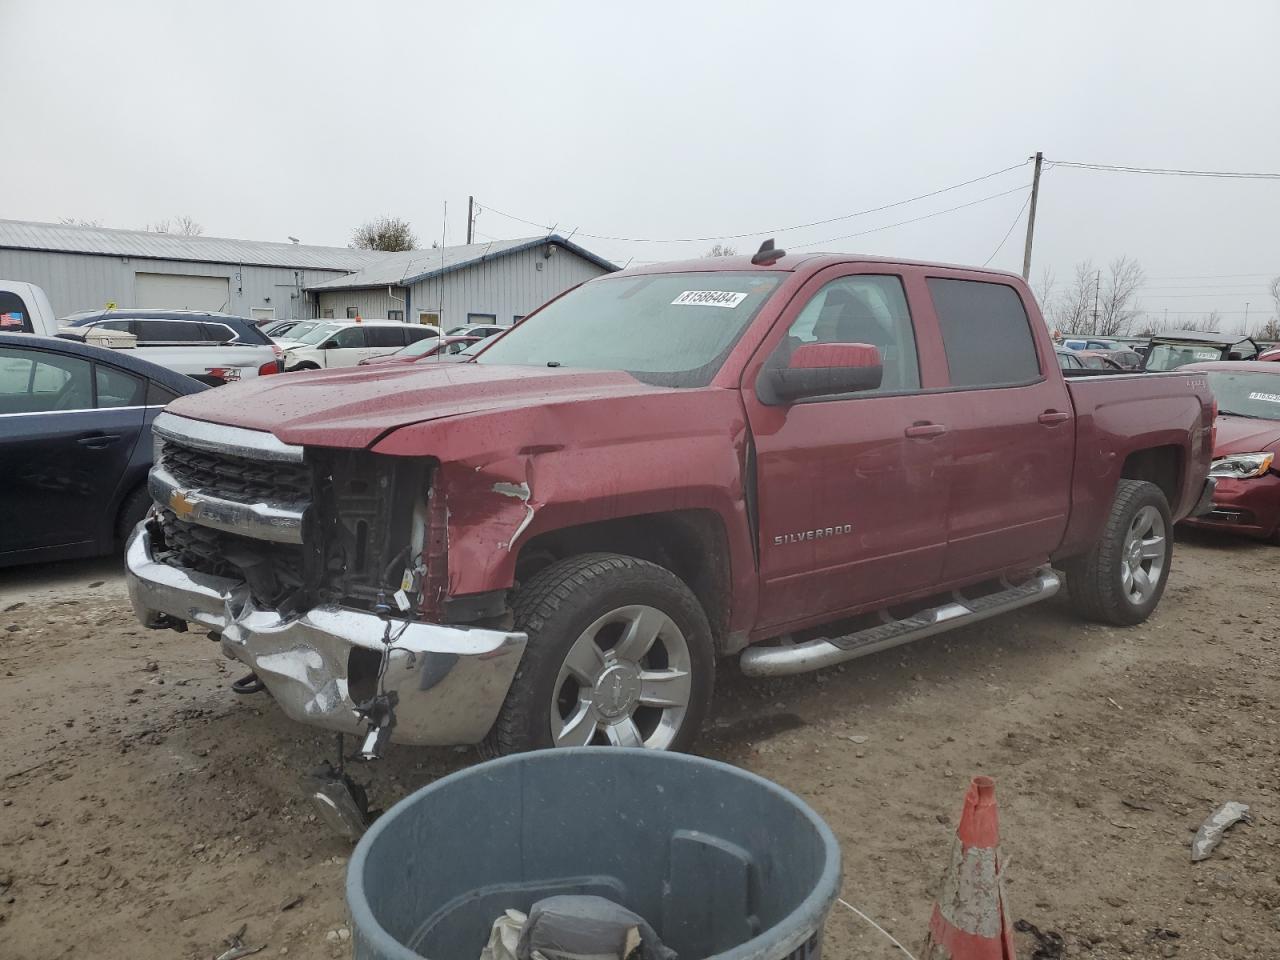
0, 250, 353, 320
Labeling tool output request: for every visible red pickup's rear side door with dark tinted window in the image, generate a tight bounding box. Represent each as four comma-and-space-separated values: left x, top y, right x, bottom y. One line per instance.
927, 273, 1075, 580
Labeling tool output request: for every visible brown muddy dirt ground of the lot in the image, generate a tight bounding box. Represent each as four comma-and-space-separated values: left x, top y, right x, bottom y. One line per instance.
0, 536, 1280, 960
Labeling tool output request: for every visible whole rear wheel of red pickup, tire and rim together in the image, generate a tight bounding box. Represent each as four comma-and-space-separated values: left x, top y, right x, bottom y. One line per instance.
1066, 480, 1174, 626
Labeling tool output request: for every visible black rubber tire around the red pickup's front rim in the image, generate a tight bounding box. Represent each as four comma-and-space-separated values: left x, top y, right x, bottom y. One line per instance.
488, 553, 716, 754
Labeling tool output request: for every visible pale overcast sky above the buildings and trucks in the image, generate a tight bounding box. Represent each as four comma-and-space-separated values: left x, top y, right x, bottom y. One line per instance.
0, 0, 1280, 325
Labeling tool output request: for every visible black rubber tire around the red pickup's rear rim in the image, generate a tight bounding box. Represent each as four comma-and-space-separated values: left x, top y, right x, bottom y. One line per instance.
1065, 480, 1174, 626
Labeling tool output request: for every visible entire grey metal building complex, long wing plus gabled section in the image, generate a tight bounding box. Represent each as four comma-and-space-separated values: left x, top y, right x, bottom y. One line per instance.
0, 220, 617, 328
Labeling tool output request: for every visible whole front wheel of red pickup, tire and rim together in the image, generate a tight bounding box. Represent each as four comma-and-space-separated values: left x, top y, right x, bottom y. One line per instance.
492, 553, 716, 753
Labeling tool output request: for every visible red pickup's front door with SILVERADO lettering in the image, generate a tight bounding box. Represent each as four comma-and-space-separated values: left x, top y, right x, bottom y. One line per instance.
742, 265, 951, 630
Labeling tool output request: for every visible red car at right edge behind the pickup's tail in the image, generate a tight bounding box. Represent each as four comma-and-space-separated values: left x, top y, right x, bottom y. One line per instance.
1179, 361, 1280, 544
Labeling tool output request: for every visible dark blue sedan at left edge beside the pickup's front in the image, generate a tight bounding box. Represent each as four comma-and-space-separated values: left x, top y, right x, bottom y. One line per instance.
0, 333, 206, 567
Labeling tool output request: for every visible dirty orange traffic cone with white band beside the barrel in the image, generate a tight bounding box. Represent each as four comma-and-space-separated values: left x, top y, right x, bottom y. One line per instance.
924, 777, 1016, 960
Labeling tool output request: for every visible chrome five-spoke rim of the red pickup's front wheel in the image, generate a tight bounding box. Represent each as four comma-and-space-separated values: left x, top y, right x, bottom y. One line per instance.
550, 605, 691, 750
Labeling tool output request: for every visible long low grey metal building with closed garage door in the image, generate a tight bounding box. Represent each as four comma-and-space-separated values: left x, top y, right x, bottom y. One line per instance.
0, 220, 388, 320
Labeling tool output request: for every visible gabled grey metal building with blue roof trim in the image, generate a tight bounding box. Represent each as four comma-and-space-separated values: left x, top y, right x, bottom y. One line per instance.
307, 234, 617, 330
